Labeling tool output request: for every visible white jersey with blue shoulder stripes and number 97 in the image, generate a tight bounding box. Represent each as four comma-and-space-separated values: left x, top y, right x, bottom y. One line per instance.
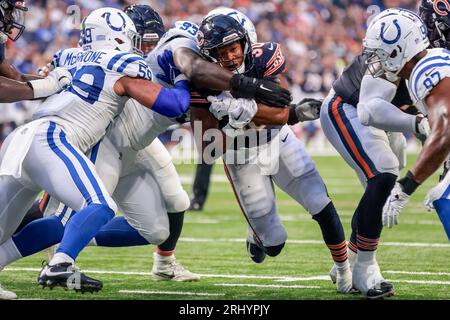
408, 48, 450, 114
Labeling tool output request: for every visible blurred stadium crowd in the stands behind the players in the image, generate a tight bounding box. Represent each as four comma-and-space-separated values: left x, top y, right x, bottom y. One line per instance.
0, 0, 418, 148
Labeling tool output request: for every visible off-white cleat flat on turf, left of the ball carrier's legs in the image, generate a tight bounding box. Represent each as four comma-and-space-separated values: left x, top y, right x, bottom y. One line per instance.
152, 252, 200, 281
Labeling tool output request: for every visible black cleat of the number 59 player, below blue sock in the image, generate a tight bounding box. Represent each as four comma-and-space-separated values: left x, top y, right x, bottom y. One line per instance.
38, 262, 103, 293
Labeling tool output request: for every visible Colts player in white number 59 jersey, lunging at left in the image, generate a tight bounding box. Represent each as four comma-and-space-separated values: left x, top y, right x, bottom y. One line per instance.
0, 8, 190, 291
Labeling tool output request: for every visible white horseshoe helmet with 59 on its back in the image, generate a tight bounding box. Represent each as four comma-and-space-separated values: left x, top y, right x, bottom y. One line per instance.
80, 8, 142, 54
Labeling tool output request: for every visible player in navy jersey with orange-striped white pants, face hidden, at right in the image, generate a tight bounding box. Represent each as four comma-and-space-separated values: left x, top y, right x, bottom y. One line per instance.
321, 6, 436, 299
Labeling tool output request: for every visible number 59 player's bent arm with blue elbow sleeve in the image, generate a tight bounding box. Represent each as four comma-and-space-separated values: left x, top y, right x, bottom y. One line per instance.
114, 77, 191, 118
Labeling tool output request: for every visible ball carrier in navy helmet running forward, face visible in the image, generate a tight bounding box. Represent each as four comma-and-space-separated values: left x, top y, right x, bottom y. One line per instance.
191, 14, 352, 293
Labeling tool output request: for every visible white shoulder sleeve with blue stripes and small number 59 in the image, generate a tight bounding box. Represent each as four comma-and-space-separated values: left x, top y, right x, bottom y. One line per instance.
106, 52, 152, 80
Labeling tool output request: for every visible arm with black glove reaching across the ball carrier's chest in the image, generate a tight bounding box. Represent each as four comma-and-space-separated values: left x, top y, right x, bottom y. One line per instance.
173, 48, 292, 107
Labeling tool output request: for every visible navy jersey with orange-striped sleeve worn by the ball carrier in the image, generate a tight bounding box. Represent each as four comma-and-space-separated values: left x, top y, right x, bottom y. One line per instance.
191, 42, 286, 109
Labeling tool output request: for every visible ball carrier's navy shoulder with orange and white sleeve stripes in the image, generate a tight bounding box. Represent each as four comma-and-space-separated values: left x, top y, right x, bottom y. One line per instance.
252, 42, 286, 77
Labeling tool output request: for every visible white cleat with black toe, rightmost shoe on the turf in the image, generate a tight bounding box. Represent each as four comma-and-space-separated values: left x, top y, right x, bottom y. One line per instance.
352, 261, 394, 300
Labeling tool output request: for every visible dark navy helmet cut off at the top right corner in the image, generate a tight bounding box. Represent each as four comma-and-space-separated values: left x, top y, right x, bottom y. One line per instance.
419, 0, 450, 49
